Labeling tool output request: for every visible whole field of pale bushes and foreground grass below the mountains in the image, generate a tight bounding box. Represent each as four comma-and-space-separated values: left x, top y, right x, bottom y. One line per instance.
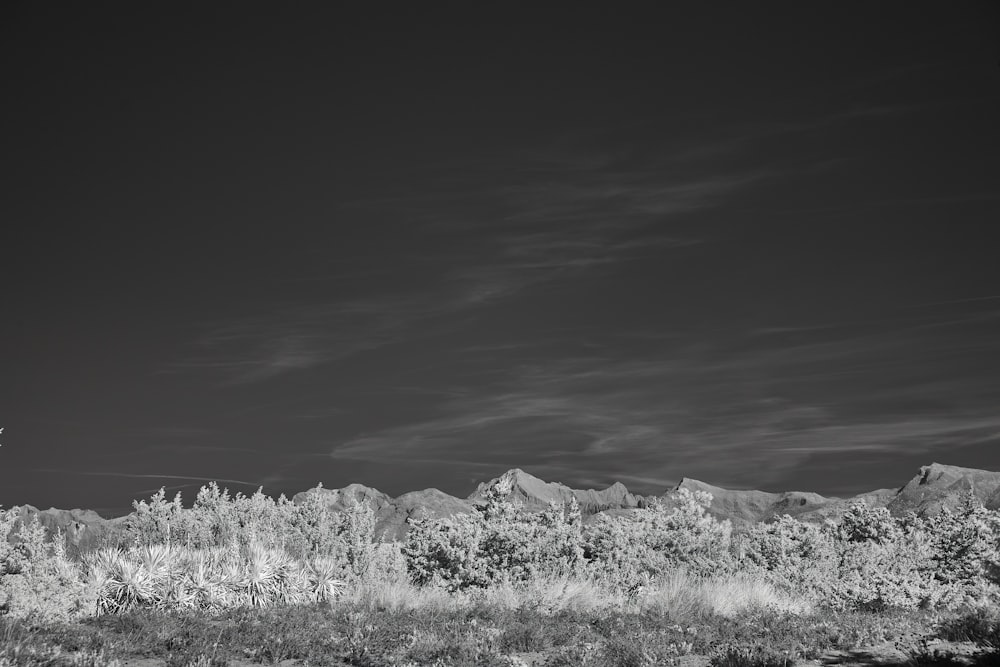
0, 484, 1000, 667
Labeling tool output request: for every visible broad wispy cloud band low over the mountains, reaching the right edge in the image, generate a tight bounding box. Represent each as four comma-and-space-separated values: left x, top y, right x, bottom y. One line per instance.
331, 306, 1000, 492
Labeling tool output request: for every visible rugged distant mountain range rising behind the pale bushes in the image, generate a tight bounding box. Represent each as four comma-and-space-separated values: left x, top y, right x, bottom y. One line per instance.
7, 463, 1000, 549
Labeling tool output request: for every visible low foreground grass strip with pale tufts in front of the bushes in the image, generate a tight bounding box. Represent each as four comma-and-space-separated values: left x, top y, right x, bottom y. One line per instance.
0, 579, 968, 667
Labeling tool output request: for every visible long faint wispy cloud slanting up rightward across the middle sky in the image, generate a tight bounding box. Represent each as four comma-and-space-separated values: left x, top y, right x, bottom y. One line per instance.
164, 151, 768, 386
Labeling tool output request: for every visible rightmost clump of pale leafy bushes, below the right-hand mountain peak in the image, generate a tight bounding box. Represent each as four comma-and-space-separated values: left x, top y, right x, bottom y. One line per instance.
736, 497, 996, 611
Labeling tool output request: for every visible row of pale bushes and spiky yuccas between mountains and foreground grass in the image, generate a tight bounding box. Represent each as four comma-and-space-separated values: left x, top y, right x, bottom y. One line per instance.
0, 483, 1000, 665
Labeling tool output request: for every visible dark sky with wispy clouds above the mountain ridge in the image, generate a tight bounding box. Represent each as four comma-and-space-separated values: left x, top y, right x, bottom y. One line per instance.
0, 1, 1000, 516
